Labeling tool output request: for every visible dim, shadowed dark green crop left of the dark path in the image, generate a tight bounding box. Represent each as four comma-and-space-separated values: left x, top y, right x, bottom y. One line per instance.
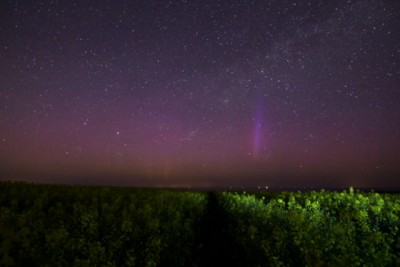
0, 183, 206, 266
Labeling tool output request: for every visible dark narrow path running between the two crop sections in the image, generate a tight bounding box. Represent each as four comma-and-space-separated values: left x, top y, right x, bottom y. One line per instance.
194, 192, 244, 266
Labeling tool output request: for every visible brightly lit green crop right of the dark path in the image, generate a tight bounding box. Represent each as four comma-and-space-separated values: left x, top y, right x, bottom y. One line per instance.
220, 188, 400, 266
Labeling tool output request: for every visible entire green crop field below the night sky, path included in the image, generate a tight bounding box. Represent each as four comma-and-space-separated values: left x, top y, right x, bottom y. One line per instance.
0, 182, 400, 266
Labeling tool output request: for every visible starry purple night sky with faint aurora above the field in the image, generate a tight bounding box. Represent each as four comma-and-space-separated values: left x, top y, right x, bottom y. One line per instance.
0, 0, 400, 188
